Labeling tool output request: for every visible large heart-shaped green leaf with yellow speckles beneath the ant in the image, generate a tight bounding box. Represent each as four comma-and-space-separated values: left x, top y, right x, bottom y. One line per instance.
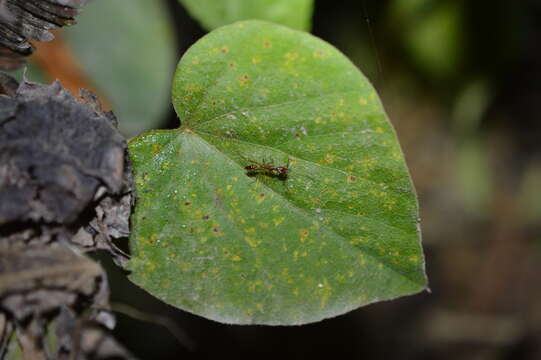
129, 21, 426, 325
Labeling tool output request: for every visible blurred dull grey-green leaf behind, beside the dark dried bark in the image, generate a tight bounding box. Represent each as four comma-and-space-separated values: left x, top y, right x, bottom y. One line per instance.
64, 0, 177, 137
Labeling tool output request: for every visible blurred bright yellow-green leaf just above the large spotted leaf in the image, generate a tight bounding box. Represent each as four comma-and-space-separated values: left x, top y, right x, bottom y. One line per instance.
180, 0, 313, 31
